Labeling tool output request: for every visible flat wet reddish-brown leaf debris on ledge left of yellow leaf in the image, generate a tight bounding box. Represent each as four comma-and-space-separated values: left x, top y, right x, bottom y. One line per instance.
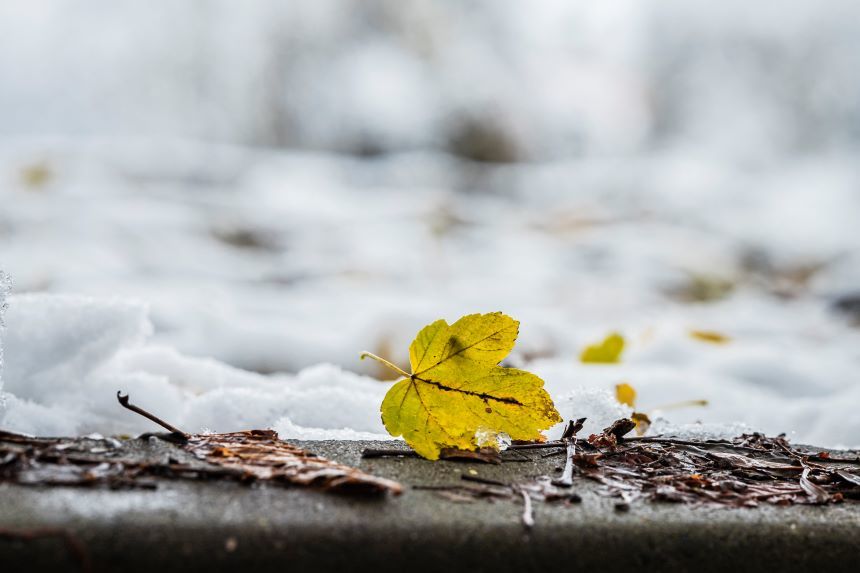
0, 430, 402, 494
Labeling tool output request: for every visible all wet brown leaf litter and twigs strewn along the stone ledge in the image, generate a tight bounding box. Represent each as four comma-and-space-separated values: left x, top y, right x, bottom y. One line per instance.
0, 406, 860, 529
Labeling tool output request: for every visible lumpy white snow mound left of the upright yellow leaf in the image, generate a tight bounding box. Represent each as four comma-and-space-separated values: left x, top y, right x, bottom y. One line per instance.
2, 294, 394, 439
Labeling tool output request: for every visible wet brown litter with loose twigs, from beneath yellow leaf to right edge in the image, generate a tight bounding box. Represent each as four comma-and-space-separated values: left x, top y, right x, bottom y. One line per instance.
365, 418, 860, 529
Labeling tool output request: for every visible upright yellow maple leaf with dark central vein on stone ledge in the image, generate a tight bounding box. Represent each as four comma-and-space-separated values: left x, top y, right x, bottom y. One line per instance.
361, 312, 561, 460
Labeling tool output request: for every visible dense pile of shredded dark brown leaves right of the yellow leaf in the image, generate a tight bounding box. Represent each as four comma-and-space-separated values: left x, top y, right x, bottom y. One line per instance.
573, 420, 860, 507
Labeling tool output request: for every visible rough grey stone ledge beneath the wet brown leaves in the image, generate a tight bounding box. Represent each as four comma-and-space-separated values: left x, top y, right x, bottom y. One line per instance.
0, 441, 860, 573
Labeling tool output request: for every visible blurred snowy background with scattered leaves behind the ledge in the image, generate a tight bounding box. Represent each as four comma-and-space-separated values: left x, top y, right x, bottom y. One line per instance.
0, 0, 860, 445
